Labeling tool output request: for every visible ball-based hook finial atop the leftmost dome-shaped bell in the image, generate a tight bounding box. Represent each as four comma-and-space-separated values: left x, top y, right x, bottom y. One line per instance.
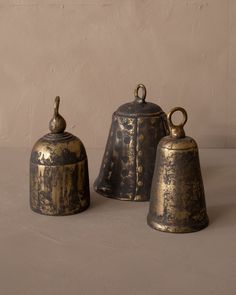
49, 96, 66, 133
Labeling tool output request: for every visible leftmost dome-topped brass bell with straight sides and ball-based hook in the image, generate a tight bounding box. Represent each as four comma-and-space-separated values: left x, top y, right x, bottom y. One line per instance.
30, 97, 90, 215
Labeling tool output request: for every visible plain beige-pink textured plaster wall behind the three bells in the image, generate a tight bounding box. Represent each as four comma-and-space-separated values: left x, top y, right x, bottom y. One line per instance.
0, 0, 236, 147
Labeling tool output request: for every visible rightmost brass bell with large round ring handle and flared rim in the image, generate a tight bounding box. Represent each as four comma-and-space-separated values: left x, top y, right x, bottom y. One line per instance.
147, 108, 208, 233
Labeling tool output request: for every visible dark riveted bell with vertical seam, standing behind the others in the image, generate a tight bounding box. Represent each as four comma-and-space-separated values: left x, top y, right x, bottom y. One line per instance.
94, 84, 169, 201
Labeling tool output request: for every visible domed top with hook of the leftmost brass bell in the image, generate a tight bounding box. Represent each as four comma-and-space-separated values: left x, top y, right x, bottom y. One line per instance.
31, 96, 87, 166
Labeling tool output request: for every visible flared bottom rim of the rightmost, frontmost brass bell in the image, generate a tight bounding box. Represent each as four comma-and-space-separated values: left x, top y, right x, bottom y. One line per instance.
147, 214, 209, 234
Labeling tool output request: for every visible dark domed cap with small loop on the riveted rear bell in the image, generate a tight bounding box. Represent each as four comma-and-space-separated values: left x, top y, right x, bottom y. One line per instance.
115, 84, 163, 117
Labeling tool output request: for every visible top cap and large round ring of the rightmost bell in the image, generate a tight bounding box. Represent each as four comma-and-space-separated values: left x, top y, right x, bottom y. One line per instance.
160, 107, 197, 150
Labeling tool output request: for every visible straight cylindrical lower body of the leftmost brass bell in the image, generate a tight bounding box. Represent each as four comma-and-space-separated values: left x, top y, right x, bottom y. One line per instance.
30, 159, 90, 216
